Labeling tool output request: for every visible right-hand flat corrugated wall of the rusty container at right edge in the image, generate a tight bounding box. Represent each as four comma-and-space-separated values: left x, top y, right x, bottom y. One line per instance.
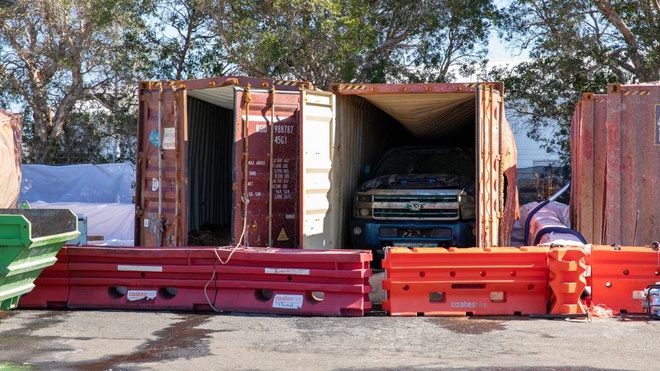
603, 83, 660, 246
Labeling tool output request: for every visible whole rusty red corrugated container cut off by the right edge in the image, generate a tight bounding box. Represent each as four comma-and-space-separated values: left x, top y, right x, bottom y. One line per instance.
570, 83, 660, 246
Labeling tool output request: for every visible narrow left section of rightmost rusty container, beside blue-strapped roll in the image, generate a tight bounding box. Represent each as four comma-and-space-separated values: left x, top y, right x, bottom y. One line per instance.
570, 93, 607, 244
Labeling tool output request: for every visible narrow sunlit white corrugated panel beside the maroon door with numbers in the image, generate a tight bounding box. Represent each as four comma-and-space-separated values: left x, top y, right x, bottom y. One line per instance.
300, 90, 340, 249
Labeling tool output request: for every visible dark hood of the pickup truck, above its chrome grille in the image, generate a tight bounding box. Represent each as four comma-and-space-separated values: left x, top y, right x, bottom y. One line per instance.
358, 174, 474, 196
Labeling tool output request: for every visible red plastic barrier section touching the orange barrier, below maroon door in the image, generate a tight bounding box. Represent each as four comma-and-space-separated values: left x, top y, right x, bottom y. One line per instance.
214, 248, 372, 316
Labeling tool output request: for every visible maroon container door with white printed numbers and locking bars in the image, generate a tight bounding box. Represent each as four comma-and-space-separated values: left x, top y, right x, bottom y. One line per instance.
232, 84, 301, 248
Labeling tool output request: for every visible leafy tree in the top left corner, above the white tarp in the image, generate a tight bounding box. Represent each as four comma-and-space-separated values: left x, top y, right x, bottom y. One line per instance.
0, 0, 148, 163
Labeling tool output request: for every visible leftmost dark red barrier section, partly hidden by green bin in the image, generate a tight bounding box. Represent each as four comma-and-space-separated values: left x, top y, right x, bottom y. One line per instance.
18, 246, 69, 309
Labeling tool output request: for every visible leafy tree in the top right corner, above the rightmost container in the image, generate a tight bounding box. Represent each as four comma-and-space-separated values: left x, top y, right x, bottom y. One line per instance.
491, 0, 660, 161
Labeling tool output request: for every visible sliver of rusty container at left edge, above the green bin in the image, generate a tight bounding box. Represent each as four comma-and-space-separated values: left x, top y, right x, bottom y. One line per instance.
0, 109, 23, 208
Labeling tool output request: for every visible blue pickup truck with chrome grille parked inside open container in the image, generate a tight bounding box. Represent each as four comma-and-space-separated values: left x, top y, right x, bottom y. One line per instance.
351, 146, 476, 267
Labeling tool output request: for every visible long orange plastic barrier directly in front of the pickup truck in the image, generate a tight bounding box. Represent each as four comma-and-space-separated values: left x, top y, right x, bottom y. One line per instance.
383, 247, 548, 316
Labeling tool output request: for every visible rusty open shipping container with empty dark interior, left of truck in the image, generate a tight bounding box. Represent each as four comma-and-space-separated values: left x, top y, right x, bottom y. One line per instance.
135, 77, 332, 248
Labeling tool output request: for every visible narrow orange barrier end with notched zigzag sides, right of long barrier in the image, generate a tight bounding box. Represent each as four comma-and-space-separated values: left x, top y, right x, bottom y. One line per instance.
548, 247, 587, 314
